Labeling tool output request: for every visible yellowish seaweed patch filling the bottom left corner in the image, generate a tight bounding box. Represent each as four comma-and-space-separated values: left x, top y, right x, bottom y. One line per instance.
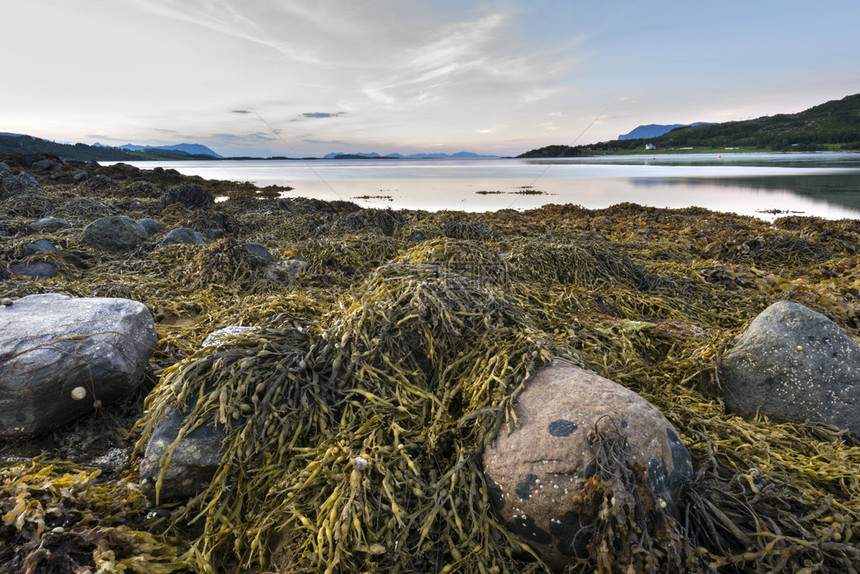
0, 461, 187, 574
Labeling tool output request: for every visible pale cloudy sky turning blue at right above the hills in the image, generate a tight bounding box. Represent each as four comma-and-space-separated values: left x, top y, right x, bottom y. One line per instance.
0, 0, 860, 156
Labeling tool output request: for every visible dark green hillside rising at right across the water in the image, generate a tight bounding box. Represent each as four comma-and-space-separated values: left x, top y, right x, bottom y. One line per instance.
519, 94, 860, 157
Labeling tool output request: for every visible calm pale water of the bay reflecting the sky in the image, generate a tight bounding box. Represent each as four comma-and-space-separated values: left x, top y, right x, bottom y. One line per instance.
114, 153, 860, 220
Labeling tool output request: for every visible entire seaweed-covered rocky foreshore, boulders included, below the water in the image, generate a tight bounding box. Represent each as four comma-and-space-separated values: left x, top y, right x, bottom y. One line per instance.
0, 154, 860, 573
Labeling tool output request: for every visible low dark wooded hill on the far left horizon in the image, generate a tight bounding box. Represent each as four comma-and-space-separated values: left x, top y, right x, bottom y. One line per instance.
0, 135, 218, 161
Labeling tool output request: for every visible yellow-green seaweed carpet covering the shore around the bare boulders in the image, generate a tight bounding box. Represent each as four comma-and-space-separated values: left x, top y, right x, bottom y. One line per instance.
0, 159, 860, 572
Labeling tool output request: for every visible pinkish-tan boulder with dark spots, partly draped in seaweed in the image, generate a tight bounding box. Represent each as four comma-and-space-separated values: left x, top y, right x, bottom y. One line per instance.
484, 359, 692, 572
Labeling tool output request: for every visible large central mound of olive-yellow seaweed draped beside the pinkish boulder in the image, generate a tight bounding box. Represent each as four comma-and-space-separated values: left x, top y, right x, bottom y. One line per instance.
136, 264, 564, 572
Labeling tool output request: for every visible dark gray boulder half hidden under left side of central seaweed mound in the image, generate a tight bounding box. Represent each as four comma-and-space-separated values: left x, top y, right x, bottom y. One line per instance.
140, 405, 226, 501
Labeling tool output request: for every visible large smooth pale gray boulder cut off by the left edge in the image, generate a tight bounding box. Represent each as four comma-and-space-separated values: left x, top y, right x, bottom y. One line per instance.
0, 293, 157, 437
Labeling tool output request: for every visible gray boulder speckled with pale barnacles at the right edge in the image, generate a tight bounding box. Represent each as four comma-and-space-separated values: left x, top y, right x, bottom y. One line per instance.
720, 301, 860, 436
